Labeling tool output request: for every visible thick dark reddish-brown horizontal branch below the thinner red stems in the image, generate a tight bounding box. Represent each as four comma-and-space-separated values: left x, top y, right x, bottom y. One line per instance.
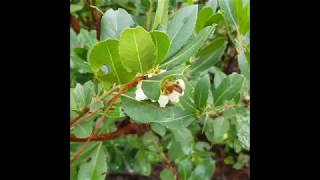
70, 123, 150, 142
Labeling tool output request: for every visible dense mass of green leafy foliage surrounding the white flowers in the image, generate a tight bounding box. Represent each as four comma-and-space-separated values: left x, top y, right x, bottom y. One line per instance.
70, 0, 250, 180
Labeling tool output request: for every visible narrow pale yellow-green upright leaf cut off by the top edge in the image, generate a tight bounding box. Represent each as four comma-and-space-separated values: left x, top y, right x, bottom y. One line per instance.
152, 0, 169, 30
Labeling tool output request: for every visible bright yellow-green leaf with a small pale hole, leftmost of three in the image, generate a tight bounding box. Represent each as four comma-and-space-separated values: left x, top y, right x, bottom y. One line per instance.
88, 39, 134, 85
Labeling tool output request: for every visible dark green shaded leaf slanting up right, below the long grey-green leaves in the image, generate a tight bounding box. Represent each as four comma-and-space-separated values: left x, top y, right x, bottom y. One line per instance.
191, 37, 227, 75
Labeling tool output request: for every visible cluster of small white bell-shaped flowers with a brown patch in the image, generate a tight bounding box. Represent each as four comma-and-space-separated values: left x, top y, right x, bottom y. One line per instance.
135, 70, 185, 107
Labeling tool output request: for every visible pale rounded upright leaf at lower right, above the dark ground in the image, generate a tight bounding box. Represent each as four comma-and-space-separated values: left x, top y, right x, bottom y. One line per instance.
205, 116, 230, 143
